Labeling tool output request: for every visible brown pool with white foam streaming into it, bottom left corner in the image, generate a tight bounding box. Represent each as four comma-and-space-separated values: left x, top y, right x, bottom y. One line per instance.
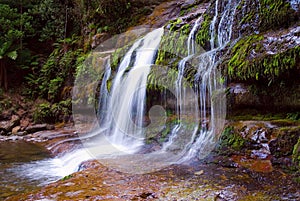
0, 141, 61, 200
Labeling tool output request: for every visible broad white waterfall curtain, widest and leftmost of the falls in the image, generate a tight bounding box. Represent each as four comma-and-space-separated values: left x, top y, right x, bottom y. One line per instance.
100, 28, 163, 152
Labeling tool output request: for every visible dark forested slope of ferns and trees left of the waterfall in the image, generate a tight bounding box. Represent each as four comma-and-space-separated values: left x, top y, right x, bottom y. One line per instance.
0, 0, 161, 122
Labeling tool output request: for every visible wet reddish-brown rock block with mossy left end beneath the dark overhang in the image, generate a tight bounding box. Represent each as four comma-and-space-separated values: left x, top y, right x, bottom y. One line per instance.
217, 121, 300, 171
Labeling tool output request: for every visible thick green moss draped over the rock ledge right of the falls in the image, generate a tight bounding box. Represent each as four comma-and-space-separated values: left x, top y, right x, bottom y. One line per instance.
227, 35, 300, 85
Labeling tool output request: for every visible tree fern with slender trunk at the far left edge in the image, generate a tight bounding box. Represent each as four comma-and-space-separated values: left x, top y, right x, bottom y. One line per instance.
0, 4, 33, 90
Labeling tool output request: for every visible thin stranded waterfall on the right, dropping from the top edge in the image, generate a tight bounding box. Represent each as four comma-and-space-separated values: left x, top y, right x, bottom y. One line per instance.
169, 0, 239, 162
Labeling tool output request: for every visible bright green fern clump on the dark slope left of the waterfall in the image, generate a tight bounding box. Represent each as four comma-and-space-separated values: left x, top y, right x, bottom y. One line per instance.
25, 39, 81, 102
